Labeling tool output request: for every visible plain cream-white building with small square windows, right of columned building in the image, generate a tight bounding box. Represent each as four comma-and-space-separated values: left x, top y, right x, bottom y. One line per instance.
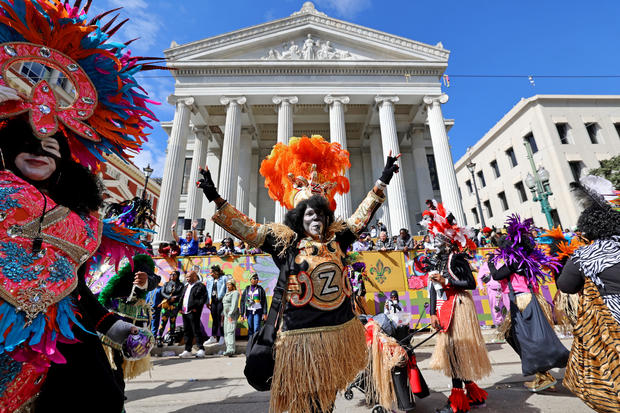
455, 95, 620, 228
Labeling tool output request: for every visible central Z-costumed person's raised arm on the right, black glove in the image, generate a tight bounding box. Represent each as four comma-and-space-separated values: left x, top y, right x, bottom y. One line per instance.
347, 151, 400, 236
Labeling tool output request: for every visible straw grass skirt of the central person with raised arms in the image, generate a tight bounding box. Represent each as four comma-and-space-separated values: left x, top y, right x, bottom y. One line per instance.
269, 318, 368, 413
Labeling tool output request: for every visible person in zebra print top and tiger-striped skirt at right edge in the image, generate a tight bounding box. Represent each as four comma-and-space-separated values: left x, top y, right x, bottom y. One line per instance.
557, 176, 620, 413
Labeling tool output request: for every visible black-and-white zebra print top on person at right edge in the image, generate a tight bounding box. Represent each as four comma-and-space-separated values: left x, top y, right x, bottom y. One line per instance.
571, 236, 620, 288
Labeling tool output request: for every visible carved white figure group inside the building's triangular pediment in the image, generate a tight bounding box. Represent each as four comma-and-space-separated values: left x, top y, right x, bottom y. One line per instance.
261, 34, 355, 60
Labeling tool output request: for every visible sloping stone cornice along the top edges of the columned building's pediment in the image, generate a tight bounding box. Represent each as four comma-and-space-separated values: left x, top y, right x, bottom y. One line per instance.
164, 13, 450, 62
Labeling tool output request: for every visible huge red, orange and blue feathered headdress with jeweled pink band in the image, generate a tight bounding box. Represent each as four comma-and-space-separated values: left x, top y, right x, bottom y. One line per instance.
0, 0, 158, 168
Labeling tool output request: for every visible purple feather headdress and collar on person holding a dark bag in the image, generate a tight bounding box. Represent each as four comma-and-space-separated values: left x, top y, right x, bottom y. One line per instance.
491, 214, 560, 284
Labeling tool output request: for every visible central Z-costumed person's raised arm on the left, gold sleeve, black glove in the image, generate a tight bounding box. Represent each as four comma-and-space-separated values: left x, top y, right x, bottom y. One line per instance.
196, 168, 267, 247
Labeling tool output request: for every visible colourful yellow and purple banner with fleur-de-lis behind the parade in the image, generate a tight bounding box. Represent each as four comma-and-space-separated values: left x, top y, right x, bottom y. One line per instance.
132, 248, 557, 335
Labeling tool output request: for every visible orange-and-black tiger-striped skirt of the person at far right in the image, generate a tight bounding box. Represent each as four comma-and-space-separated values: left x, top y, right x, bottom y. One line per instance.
563, 278, 620, 413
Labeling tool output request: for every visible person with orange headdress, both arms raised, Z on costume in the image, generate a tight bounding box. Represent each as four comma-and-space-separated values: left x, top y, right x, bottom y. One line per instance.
199, 136, 400, 413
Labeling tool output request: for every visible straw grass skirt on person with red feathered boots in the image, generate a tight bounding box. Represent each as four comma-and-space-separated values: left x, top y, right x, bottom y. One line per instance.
429, 291, 491, 381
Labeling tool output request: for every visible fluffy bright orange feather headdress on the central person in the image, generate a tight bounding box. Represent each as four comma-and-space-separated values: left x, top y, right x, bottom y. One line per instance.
260, 135, 351, 210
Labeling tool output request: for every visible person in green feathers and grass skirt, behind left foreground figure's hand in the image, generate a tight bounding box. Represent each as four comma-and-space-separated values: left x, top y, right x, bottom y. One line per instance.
98, 254, 160, 391
